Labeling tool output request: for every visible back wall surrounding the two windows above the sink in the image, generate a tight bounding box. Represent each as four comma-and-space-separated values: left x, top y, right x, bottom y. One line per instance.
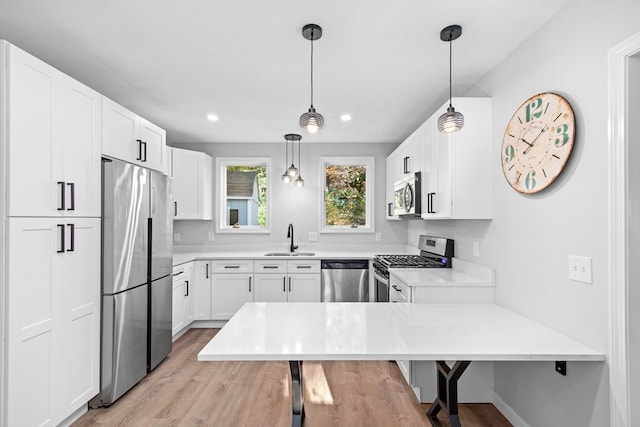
172, 142, 407, 249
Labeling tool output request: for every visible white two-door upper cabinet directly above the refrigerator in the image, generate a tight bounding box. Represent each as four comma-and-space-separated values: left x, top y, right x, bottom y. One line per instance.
102, 97, 169, 174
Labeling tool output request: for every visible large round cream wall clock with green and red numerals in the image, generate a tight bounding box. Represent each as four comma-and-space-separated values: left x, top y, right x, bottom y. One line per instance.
502, 92, 576, 194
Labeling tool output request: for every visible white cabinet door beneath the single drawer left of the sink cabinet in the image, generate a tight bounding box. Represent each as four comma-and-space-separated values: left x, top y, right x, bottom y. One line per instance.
211, 273, 254, 320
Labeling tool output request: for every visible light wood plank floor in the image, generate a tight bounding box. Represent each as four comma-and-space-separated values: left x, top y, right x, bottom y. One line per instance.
73, 329, 511, 427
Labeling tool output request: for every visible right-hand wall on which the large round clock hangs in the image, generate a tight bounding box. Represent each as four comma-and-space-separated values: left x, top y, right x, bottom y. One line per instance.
408, 0, 640, 427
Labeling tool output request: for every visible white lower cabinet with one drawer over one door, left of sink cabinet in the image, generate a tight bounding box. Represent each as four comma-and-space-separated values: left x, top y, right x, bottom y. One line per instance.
210, 259, 254, 320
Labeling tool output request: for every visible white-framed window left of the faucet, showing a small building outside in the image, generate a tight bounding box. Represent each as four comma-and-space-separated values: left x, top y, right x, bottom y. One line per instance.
216, 157, 271, 233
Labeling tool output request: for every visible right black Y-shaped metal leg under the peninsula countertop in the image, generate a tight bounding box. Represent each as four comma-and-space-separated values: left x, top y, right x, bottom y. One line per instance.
427, 360, 471, 427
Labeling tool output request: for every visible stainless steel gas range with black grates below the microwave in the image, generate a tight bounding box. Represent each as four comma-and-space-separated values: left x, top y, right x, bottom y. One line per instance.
373, 235, 453, 302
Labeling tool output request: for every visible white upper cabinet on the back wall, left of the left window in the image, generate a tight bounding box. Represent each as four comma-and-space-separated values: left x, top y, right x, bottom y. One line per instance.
170, 148, 213, 220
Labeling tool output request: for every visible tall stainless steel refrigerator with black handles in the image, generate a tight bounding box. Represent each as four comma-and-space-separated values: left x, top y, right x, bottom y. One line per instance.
90, 159, 173, 407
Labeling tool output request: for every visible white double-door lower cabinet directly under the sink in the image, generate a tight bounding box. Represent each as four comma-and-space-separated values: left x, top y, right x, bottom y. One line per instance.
255, 260, 320, 302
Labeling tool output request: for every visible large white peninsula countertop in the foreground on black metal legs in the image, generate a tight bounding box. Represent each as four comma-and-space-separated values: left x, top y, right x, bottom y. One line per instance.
198, 303, 604, 361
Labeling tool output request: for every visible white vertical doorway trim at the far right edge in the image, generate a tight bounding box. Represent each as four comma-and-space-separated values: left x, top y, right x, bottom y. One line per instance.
608, 33, 640, 427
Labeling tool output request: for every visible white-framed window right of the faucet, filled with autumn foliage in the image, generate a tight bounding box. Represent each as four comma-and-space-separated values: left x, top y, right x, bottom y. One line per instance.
321, 157, 374, 233
